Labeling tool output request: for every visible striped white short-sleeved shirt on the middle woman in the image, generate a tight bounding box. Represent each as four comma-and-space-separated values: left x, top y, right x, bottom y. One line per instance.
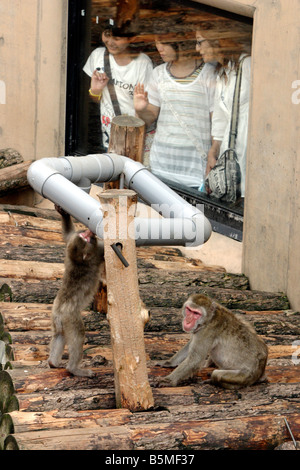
148, 64, 216, 187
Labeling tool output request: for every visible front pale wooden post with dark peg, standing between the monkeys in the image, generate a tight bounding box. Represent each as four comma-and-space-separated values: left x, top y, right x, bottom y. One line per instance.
99, 189, 154, 411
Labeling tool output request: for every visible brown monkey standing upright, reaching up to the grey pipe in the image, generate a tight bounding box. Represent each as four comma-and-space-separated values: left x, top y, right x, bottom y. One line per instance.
48, 206, 104, 377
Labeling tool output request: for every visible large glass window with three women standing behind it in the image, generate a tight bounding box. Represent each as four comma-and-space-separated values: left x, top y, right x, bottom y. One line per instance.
66, 0, 252, 238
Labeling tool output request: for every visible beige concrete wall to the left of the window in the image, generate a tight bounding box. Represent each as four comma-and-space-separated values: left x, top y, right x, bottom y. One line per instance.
0, 0, 68, 160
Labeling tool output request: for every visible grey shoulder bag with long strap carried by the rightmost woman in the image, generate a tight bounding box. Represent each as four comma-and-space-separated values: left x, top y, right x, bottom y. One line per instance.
205, 56, 248, 203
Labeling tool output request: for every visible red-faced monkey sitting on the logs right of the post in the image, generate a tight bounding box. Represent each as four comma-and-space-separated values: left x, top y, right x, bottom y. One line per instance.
158, 294, 268, 390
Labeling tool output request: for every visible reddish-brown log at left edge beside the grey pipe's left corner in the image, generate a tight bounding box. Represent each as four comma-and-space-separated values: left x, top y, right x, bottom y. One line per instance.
0, 161, 32, 197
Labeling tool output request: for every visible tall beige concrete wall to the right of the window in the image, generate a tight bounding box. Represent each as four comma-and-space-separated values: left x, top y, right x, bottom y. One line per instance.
188, 0, 300, 310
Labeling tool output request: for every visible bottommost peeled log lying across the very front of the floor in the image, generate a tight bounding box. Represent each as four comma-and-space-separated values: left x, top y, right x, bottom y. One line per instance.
10, 414, 300, 450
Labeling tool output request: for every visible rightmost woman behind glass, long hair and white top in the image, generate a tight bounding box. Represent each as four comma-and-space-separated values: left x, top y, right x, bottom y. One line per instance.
196, 31, 251, 197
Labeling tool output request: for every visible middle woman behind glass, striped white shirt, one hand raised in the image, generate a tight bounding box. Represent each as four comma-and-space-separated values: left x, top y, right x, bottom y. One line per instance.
134, 37, 215, 188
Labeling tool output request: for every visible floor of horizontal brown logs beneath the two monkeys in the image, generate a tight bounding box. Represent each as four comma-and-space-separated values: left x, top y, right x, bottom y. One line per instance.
0, 206, 300, 450
